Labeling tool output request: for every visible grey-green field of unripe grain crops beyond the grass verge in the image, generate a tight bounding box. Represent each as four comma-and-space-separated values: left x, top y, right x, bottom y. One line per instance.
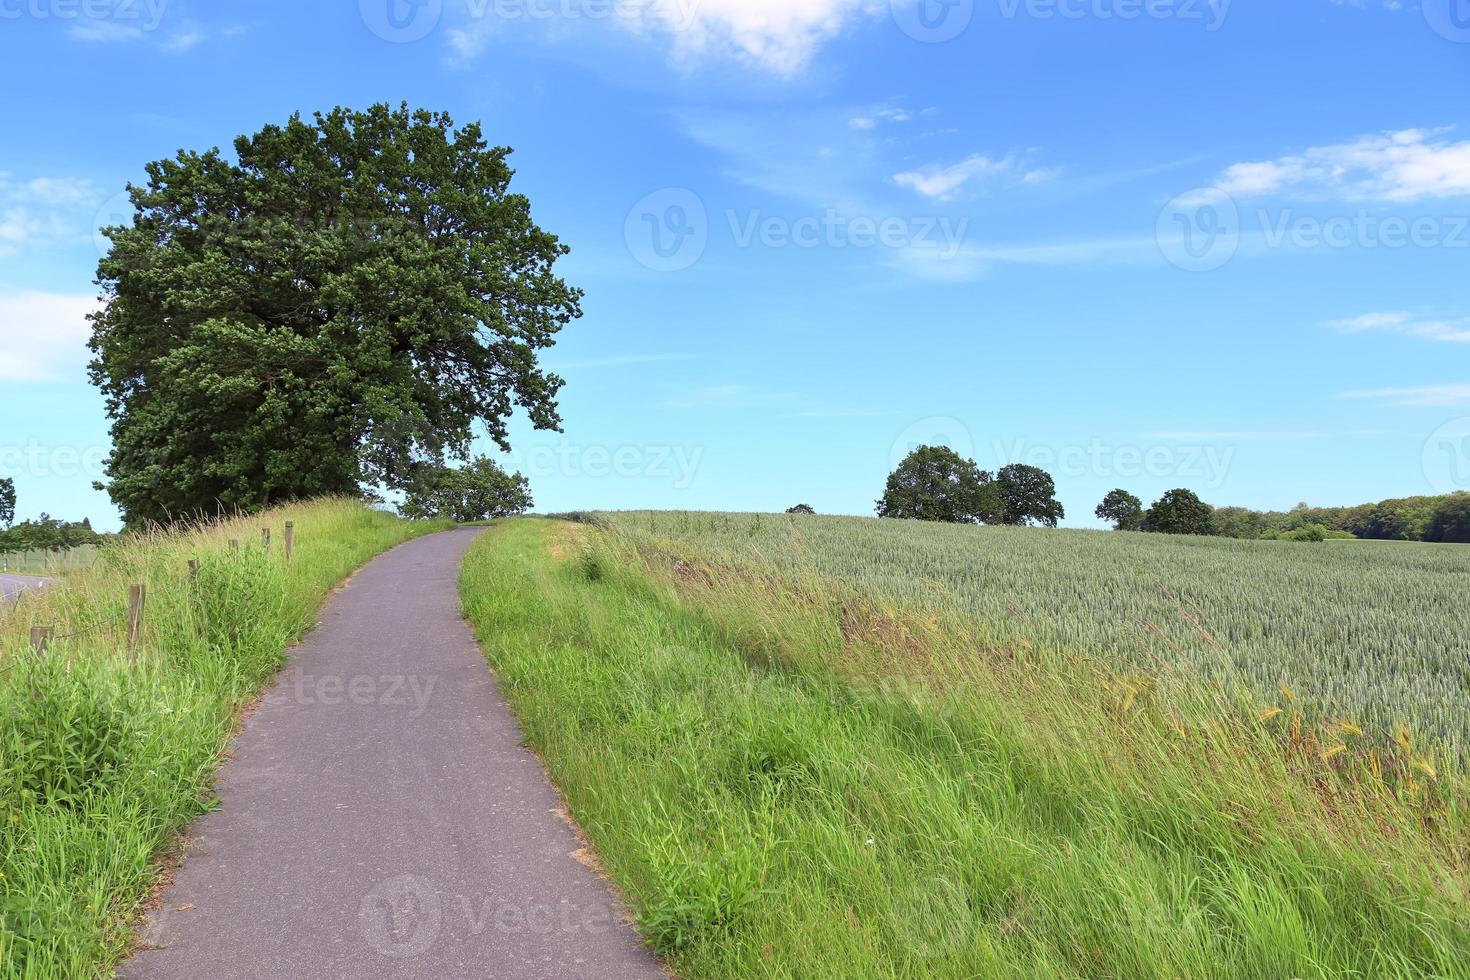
603, 511, 1470, 763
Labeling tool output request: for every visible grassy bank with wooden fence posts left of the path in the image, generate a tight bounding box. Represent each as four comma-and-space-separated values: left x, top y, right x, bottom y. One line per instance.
0, 501, 437, 977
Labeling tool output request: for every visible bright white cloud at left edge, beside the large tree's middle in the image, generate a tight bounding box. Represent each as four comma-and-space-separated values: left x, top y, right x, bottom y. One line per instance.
0, 292, 97, 382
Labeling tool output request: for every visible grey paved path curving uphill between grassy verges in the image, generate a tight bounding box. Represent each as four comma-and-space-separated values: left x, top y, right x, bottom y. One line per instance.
121, 529, 666, 980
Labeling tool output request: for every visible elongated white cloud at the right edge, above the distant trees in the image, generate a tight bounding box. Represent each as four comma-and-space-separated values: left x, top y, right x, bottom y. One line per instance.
1219, 129, 1470, 201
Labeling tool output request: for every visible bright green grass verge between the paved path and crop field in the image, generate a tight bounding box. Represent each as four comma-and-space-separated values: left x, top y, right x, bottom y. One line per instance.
462, 522, 1470, 977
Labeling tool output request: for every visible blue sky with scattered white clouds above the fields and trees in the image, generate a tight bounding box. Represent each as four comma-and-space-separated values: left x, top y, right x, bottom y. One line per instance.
0, 0, 1470, 526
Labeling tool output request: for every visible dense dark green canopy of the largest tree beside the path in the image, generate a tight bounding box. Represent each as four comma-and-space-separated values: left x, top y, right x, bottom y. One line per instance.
91, 104, 581, 523
